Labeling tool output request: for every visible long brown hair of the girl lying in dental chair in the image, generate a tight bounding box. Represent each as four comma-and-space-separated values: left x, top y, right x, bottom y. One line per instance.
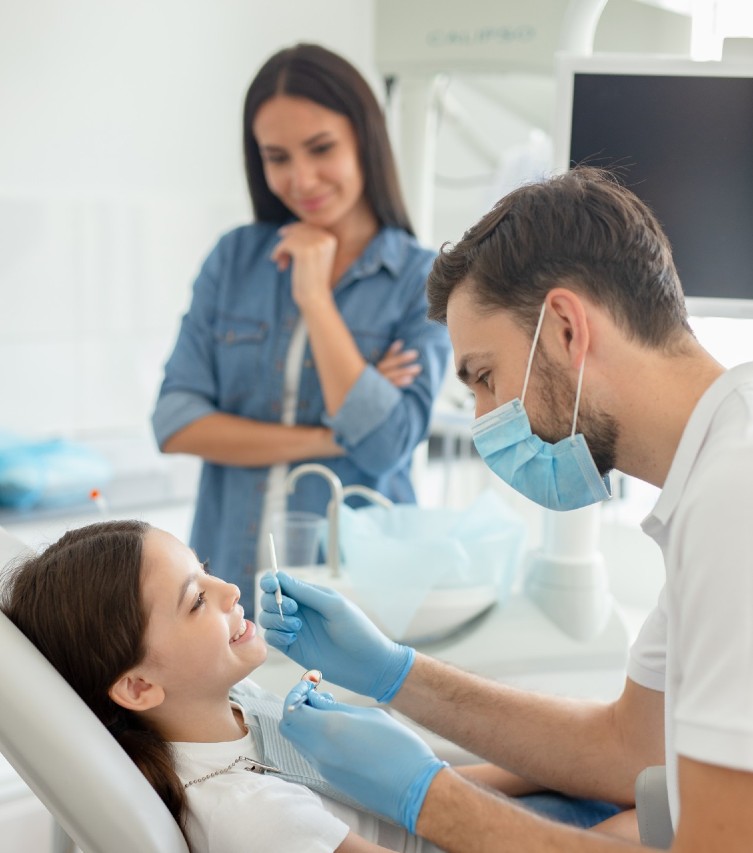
0, 521, 186, 840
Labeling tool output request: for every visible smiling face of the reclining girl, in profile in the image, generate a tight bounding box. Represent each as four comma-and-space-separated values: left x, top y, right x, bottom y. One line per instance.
141, 528, 267, 701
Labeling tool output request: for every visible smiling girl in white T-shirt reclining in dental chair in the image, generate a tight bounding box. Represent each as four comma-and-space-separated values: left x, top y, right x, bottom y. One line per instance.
0, 521, 435, 853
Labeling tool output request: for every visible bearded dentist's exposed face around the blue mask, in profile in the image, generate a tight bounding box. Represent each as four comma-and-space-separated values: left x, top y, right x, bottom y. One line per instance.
447, 285, 618, 476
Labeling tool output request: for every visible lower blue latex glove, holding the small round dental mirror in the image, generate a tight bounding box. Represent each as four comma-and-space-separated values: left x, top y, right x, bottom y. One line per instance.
278, 680, 448, 833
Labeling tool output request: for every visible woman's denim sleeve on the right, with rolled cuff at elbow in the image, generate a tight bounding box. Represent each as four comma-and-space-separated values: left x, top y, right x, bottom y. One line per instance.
323, 253, 450, 476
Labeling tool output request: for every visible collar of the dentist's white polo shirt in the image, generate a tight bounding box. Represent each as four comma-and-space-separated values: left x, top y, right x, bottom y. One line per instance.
641, 362, 753, 540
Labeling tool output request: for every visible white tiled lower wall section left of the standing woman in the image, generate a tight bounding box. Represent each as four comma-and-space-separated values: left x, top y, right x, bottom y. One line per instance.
0, 197, 247, 435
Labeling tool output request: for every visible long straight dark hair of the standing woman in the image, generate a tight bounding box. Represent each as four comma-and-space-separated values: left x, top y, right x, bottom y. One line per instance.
243, 44, 413, 234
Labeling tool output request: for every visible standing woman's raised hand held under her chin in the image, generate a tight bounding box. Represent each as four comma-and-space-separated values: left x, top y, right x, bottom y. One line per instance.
271, 222, 337, 310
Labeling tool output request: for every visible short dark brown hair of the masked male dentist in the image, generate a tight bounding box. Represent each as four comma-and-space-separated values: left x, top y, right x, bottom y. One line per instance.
427, 167, 692, 352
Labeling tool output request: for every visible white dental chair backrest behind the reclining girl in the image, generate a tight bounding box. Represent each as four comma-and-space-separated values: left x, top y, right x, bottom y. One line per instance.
0, 527, 188, 853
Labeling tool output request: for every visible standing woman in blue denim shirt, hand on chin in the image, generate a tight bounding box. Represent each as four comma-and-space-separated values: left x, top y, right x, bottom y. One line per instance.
153, 44, 450, 612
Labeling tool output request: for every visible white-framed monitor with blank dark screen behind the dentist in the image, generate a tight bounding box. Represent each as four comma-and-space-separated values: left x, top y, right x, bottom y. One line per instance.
554, 54, 753, 317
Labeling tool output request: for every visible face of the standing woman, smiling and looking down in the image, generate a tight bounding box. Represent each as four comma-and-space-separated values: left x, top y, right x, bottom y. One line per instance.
253, 95, 368, 229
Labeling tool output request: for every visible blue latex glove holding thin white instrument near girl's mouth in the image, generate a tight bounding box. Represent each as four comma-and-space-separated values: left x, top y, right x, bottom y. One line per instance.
258, 572, 416, 702
